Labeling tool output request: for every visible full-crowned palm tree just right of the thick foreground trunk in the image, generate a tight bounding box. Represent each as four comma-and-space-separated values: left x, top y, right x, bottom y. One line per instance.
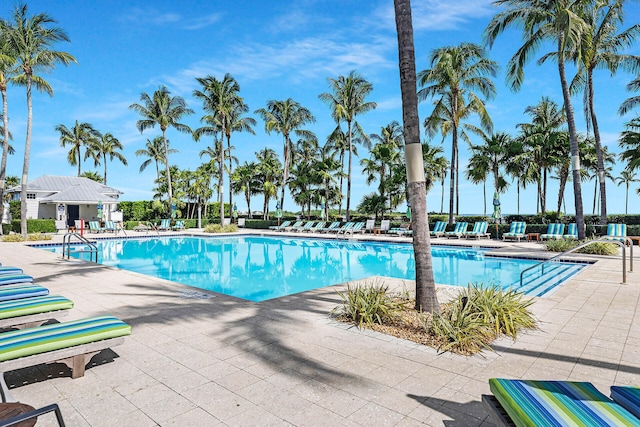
418, 43, 498, 223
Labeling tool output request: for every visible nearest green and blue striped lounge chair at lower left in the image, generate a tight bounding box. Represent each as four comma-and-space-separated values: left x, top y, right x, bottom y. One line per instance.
0, 316, 131, 390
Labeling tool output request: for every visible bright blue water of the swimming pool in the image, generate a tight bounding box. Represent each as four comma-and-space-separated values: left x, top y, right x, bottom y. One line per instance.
33, 236, 584, 301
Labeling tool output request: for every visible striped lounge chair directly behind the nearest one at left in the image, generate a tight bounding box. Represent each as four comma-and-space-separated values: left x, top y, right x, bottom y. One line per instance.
0, 295, 73, 328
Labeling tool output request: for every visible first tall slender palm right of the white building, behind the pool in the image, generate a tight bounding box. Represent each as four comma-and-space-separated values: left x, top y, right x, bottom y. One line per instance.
129, 86, 193, 217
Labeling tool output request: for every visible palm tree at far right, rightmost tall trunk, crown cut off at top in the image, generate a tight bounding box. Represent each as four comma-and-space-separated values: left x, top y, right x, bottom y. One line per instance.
571, 0, 640, 224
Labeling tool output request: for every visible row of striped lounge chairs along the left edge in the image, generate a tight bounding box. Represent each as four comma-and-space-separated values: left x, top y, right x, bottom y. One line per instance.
0, 267, 131, 401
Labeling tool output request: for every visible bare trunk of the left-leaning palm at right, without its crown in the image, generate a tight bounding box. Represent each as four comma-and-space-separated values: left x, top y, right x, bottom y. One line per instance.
558, 41, 586, 240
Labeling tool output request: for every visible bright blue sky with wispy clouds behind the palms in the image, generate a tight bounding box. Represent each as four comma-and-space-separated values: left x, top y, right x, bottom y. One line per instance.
0, 0, 640, 214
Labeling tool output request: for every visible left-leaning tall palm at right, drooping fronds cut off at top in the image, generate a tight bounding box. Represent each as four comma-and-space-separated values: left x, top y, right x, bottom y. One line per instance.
484, 0, 588, 240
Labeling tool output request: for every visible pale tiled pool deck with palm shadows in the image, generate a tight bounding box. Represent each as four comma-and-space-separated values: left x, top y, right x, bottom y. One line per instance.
0, 230, 640, 426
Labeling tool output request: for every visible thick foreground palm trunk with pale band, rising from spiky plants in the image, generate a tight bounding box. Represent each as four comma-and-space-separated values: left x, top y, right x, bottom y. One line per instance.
393, 0, 440, 313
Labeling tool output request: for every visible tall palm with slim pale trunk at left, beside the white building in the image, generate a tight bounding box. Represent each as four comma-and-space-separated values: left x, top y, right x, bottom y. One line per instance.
2, 4, 77, 239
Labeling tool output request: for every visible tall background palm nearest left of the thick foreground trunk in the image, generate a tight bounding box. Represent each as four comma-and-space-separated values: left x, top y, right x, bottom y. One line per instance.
318, 71, 377, 221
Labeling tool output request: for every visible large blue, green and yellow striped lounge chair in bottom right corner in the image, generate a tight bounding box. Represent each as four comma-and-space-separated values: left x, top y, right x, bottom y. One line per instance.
482, 378, 640, 426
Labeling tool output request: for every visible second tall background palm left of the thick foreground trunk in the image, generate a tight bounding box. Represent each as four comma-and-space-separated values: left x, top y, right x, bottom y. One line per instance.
255, 98, 316, 208
